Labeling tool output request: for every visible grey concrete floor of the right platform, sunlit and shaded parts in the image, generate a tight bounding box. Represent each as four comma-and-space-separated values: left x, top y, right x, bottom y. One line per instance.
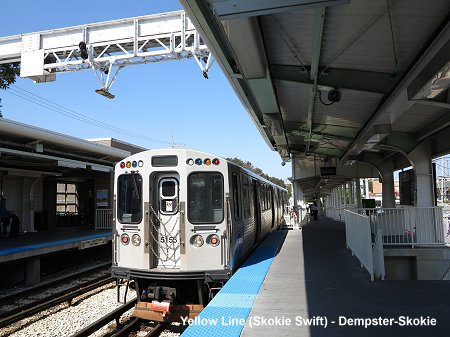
241, 218, 450, 337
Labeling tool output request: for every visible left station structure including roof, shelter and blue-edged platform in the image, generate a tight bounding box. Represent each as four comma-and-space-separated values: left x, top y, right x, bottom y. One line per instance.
0, 118, 145, 288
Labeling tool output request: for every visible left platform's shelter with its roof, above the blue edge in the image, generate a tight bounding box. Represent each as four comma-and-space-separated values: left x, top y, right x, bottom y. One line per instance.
0, 118, 144, 232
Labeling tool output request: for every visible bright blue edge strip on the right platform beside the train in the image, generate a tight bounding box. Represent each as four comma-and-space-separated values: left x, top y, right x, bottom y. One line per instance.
181, 230, 287, 337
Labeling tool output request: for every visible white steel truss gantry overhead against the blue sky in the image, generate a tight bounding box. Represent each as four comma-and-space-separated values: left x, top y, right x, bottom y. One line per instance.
0, 11, 214, 98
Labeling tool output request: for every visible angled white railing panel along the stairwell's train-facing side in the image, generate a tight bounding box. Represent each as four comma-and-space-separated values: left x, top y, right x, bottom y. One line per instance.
344, 210, 375, 281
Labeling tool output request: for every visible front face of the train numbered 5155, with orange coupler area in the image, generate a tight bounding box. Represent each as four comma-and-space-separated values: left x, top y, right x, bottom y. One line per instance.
112, 149, 230, 321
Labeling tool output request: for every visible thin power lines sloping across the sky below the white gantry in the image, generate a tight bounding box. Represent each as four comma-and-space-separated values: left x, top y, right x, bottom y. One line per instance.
6, 84, 178, 145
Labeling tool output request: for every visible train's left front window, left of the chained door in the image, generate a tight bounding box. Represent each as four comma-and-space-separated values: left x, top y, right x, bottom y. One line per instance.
117, 173, 142, 223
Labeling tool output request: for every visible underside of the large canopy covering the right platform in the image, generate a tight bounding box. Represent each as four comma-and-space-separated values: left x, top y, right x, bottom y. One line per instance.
181, 0, 450, 193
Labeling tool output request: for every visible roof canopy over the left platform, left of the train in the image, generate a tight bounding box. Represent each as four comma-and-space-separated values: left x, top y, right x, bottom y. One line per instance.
0, 118, 130, 175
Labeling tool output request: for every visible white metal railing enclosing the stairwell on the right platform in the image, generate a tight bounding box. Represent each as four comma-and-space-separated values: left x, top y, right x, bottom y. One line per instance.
342, 207, 448, 281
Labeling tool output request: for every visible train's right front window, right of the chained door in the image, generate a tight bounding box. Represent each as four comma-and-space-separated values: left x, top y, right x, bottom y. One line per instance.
188, 172, 223, 224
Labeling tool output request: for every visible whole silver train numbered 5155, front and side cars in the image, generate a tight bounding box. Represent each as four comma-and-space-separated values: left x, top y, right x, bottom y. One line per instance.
112, 149, 287, 321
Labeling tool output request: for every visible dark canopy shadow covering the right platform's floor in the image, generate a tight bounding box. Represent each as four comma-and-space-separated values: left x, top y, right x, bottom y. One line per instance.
299, 217, 450, 337
